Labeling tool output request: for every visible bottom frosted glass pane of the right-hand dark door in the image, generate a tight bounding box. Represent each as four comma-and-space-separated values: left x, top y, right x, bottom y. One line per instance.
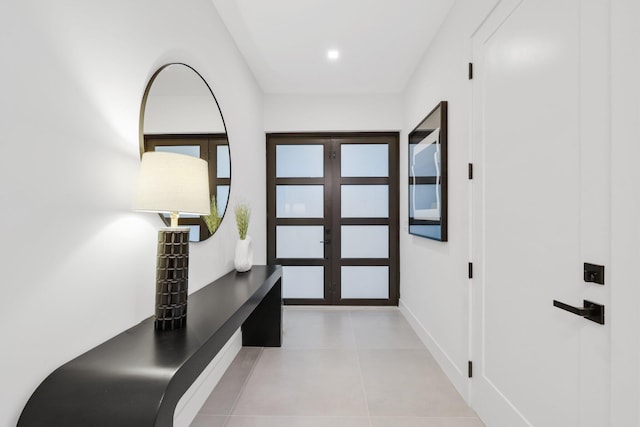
340, 266, 389, 299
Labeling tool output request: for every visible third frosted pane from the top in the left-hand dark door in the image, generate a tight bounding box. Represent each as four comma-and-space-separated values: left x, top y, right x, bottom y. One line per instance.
276, 225, 324, 258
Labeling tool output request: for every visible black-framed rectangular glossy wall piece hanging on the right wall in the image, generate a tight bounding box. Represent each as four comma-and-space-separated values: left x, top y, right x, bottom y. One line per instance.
409, 101, 447, 242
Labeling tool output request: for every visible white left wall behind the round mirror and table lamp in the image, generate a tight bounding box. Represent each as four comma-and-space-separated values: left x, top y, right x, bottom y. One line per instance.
0, 0, 266, 426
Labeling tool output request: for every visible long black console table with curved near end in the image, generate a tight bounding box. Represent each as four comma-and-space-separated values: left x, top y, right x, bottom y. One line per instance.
18, 266, 282, 427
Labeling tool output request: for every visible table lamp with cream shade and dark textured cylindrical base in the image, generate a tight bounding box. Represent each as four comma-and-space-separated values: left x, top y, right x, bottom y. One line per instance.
134, 151, 210, 330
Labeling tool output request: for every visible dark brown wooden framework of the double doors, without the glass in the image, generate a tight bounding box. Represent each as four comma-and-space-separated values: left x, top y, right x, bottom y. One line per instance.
267, 132, 400, 306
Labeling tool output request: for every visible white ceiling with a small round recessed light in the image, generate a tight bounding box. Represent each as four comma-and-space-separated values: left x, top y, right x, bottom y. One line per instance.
212, 0, 455, 94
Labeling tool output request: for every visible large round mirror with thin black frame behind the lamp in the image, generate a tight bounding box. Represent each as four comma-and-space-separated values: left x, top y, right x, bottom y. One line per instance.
140, 64, 231, 242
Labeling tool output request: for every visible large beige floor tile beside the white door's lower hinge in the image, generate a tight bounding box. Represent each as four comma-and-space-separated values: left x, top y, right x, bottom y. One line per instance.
359, 349, 476, 417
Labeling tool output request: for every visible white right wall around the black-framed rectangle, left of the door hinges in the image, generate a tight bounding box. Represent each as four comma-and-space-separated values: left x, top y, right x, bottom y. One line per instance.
400, 0, 496, 399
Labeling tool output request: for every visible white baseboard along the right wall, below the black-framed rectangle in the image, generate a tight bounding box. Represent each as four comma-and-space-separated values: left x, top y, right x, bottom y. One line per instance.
398, 299, 470, 403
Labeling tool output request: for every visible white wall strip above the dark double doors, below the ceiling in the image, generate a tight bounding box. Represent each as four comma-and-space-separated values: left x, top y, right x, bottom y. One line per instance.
264, 94, 402, 132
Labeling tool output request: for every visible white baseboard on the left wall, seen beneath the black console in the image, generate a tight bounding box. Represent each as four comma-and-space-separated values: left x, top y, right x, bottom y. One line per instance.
173, 329, 242, 427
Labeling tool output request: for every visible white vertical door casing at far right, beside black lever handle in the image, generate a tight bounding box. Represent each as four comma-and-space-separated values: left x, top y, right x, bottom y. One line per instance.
610, 0, 640, 426
